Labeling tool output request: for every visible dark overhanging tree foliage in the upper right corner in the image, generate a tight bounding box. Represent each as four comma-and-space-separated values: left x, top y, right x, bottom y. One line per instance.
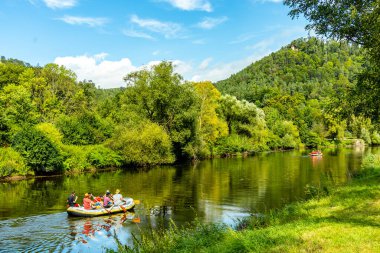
284, 0, 380, 120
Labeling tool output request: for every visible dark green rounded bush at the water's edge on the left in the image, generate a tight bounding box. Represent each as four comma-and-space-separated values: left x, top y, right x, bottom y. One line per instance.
12, 127, 62, 173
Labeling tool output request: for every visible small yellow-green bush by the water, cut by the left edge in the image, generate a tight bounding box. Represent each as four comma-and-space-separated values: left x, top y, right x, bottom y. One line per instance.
0, 148, 32, 177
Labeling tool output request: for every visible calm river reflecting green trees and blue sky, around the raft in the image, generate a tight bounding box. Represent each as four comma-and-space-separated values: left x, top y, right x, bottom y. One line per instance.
0, 148, 380, 252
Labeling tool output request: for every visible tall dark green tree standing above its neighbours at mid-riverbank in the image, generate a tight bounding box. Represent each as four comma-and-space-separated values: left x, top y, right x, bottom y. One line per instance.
121, 62, 198, 157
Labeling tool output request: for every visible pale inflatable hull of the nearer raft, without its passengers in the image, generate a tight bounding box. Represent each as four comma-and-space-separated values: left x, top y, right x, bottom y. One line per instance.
67, 198, 135, 217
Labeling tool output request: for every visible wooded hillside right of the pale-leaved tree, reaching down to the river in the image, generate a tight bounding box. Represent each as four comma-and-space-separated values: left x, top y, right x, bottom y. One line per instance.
215, 38, 378, 146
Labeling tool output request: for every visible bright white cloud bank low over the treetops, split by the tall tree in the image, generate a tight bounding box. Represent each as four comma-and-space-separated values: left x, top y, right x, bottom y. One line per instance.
54, 52, 269, 88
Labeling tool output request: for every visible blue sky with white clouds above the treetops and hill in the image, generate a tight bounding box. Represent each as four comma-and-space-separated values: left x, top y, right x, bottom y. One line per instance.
0, 0, 307, 88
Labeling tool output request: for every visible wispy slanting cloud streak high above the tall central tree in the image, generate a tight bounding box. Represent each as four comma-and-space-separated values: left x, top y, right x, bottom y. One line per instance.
131, 15, 182, 38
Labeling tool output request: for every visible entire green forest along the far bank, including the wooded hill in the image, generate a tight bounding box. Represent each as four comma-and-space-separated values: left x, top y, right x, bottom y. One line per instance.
0, 38, 380, 177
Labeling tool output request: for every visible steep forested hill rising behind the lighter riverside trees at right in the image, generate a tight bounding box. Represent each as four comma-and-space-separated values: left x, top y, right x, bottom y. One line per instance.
215, 38, 363, 107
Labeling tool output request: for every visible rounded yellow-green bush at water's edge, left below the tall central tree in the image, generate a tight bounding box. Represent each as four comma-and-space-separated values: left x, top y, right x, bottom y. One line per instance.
108, 122, 174, 165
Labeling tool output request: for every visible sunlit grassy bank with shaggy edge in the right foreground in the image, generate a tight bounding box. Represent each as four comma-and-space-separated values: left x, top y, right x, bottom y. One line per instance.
111, 155, 380, 253
